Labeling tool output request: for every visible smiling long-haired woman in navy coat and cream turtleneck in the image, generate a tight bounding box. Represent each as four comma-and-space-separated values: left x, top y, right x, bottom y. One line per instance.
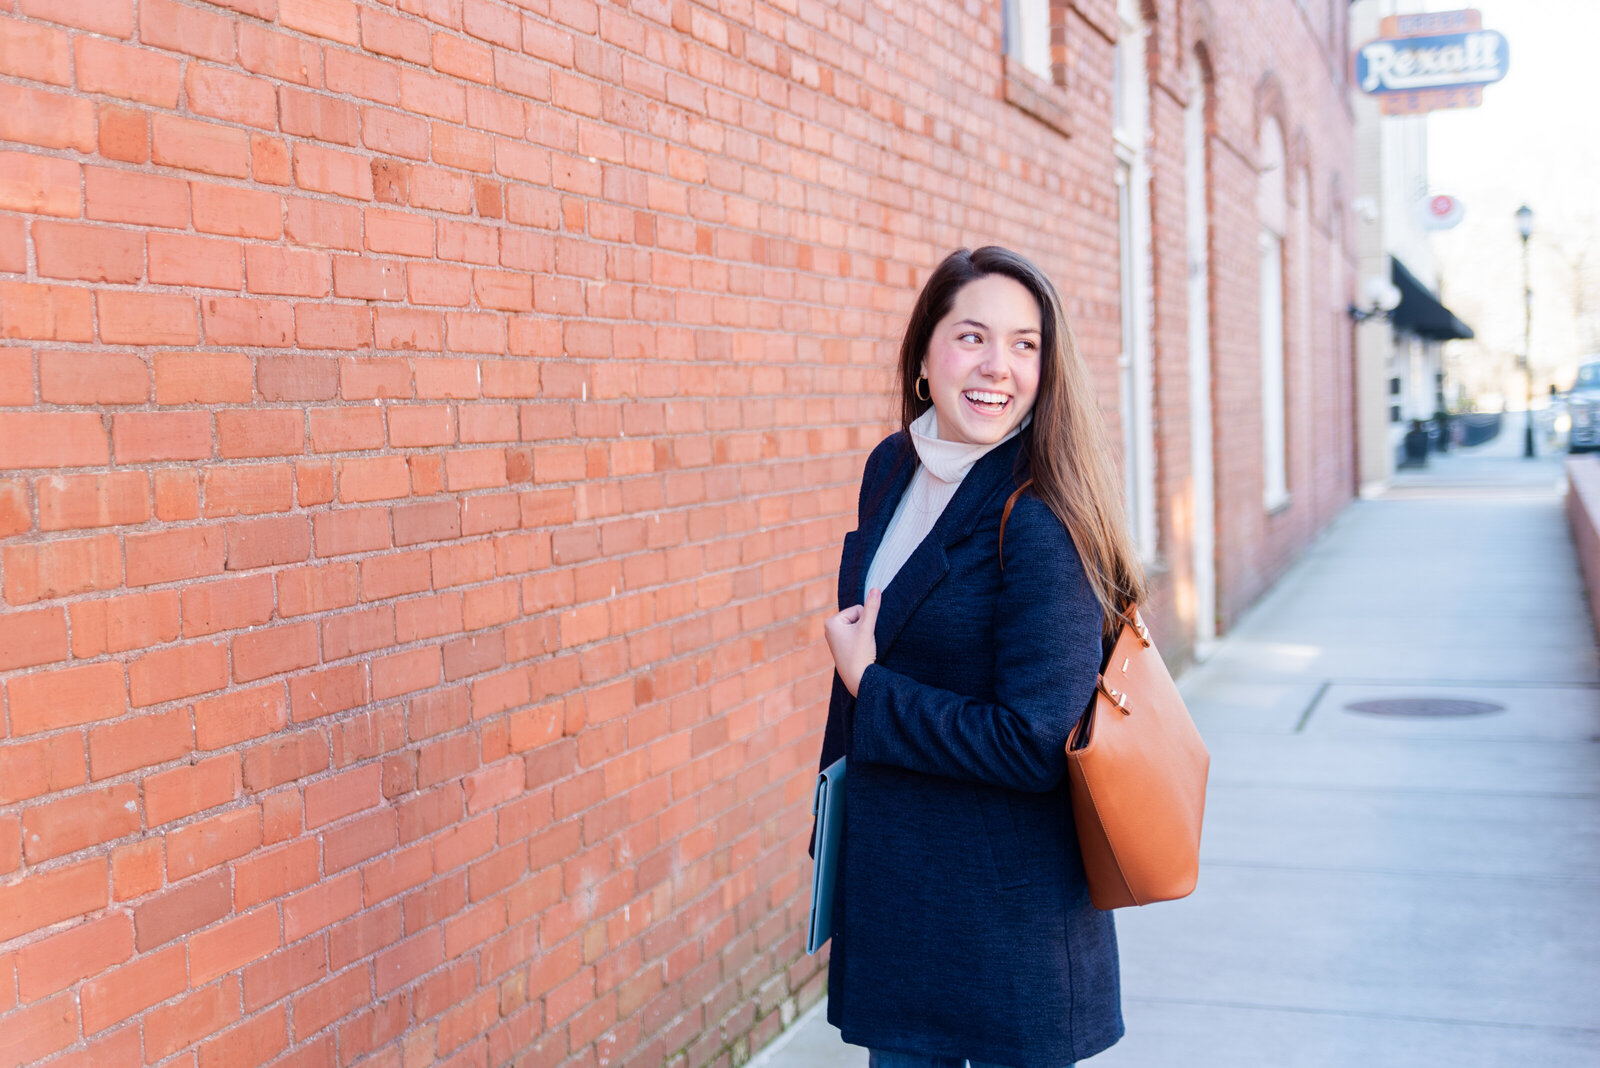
821, 246, 1144, 1068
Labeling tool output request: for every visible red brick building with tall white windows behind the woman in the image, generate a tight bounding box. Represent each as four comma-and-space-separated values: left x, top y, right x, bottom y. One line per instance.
0, 0, 1354, 1068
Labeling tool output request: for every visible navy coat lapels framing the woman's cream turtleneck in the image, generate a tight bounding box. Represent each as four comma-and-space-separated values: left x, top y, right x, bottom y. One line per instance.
864, 432, 1026, 660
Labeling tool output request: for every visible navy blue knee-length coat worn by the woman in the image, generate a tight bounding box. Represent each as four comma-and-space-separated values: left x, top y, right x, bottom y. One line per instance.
813, 428, 1123, 1068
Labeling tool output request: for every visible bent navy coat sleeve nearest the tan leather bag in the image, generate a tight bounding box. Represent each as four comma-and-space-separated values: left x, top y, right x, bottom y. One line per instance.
850, 496, 1101, 791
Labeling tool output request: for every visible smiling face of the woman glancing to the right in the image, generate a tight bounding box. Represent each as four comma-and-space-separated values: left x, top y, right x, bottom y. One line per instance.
922, 275, 1042, 444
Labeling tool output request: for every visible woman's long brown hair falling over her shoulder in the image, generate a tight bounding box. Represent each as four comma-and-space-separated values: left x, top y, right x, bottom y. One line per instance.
899, 245, 1146, 633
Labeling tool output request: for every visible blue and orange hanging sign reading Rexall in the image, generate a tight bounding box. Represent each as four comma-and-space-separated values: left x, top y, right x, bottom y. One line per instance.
1350, 10, 1510, 115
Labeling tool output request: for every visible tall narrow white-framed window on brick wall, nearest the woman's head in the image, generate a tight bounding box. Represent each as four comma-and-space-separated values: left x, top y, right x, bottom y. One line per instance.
1112, 0, 1155, 558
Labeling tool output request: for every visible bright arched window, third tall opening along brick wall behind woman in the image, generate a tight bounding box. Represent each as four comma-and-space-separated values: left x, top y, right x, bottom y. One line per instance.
1256, 117, 1290, 512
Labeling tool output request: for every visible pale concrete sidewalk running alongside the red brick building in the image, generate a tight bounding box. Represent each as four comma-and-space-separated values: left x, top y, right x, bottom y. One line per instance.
754, 433, 1600, 1068
